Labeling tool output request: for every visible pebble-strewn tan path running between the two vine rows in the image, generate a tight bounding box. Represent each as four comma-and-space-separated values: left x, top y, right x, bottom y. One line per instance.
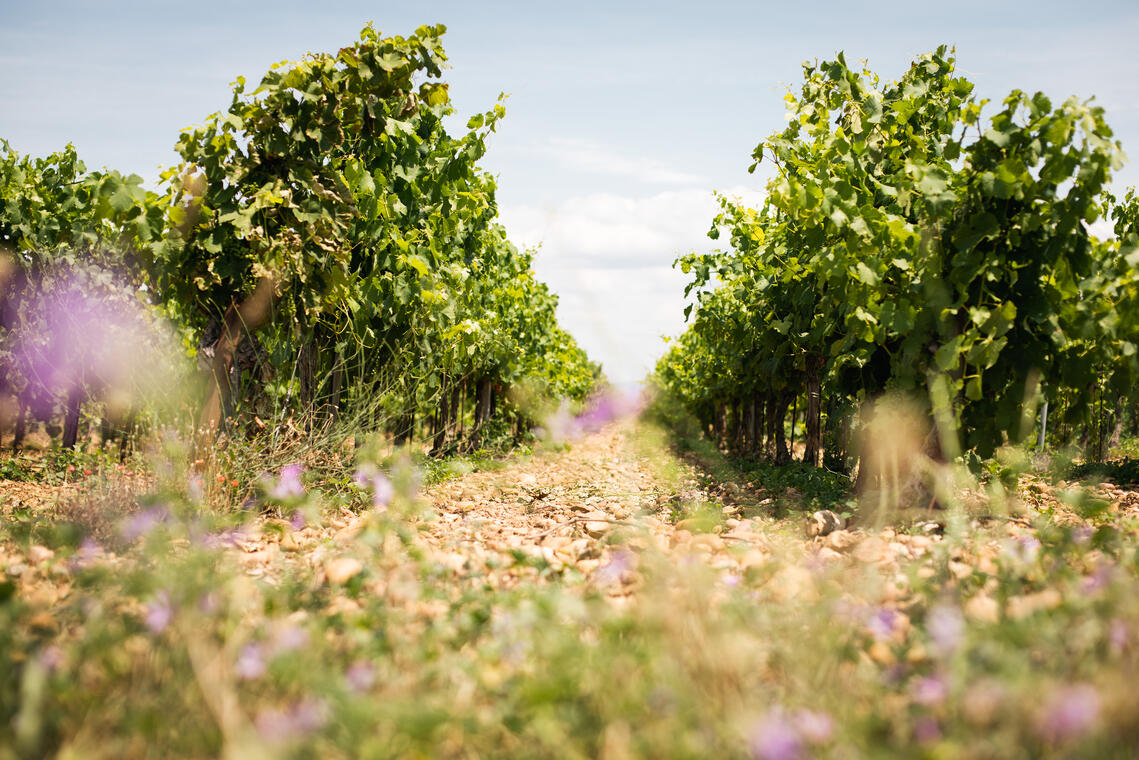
421, 419, 771, 595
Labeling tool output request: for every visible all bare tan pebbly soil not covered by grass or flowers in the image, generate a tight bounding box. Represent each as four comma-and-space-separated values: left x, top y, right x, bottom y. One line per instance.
0, 412, 1139, 606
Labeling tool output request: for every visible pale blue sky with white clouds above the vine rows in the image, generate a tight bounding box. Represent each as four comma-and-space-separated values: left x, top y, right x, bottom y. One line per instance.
0, 0, 1139, 383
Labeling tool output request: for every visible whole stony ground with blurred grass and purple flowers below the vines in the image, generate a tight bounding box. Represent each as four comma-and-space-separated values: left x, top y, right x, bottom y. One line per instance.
0, 412, 1139, 760
